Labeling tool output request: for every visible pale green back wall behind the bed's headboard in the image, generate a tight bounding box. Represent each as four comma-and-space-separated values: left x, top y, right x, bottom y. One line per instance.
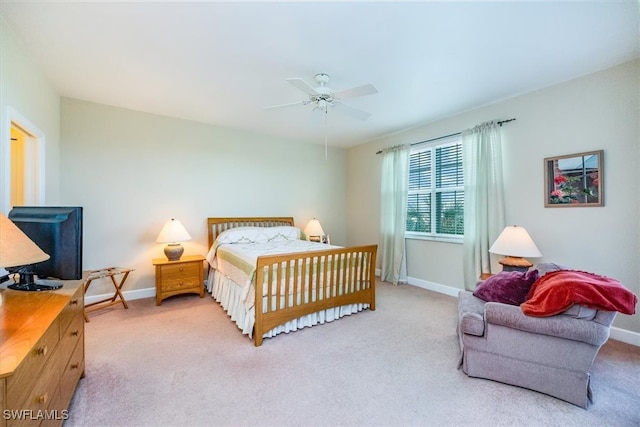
60, 98, 346, 295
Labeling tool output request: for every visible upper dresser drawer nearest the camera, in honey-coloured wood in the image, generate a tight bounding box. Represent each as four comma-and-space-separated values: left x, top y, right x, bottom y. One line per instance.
7, 318, 60, 409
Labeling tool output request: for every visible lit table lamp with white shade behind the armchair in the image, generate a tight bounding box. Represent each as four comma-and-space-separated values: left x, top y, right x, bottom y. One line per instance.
489, 225, 542, 271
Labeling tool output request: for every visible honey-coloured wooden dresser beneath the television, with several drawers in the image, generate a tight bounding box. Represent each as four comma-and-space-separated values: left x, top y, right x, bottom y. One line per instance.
0, 280, 84, 427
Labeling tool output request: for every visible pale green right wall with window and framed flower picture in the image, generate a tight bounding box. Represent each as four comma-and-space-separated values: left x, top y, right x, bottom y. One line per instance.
347, 60, 640, 333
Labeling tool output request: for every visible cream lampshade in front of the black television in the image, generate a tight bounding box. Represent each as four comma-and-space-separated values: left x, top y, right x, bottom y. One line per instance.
0, 214, 49, 267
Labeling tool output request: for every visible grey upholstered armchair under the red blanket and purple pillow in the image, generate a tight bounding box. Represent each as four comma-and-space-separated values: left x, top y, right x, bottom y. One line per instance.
458, 291, 616, 408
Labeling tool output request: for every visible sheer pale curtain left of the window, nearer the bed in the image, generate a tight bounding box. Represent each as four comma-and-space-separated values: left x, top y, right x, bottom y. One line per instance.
379, 145, 410, 285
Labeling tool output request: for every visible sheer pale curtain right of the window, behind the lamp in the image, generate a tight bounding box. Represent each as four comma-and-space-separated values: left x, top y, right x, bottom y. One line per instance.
462, 122, 505, 290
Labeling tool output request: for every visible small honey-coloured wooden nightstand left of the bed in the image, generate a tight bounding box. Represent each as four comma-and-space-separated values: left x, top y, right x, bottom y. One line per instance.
153, 255, 204, 305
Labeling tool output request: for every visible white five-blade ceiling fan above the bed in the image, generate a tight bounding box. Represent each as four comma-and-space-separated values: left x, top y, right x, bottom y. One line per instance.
265, 73, 378, 120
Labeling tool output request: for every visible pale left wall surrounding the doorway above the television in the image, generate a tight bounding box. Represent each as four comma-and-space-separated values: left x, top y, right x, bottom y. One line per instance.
0, 16, 60, 214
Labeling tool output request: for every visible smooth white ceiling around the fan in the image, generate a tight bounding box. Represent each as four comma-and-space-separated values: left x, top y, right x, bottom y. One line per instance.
0, 0, 640, 147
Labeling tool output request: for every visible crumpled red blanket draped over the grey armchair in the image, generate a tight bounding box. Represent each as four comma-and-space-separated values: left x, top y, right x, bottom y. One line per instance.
520, 270, 638, 317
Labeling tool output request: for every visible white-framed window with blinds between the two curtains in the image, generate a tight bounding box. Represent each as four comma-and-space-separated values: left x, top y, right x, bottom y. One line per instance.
406, 135, 464, 238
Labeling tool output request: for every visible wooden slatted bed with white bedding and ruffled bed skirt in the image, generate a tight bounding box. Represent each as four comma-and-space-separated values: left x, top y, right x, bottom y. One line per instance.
207, 217, 377, 347
